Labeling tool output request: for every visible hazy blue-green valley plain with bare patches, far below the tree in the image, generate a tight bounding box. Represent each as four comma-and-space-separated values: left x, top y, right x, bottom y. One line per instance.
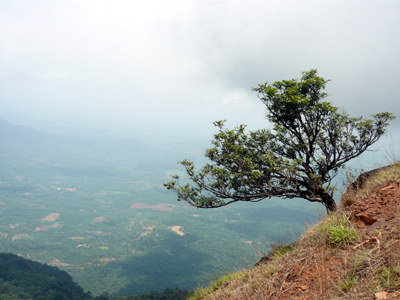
0, 121, 323, 296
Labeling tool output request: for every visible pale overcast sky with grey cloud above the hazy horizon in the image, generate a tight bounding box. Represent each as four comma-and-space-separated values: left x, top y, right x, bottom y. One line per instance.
0, 0, 400, 149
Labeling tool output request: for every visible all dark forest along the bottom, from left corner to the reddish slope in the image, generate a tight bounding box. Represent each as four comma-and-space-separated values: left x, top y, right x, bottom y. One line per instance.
0, 253, 190, 300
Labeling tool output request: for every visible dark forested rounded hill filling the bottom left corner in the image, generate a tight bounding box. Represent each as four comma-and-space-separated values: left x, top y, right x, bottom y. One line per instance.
0, 253, 92, 300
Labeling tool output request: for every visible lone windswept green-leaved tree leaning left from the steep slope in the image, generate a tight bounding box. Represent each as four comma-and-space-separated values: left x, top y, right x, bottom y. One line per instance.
164, 70, 395, 212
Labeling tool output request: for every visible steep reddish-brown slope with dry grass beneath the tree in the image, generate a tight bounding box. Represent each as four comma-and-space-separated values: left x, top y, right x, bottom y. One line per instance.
192, 165, 400, 300
